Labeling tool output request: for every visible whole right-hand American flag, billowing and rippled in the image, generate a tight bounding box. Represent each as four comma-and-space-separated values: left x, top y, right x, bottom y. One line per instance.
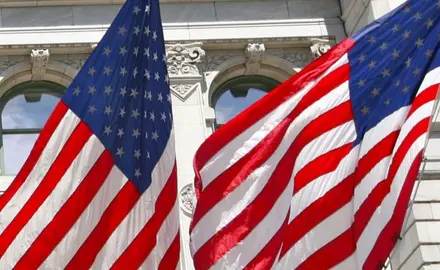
191, 0, 440, 269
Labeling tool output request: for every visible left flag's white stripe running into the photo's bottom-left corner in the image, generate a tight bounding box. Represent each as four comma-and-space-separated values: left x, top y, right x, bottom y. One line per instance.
0, 135, 104, 269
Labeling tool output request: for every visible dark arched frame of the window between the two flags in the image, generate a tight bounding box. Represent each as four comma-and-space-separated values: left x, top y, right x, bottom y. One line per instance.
211, 75, 281, 130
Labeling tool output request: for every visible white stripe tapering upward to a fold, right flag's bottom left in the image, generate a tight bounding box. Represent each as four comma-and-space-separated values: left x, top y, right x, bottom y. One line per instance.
211, 179, 293, 270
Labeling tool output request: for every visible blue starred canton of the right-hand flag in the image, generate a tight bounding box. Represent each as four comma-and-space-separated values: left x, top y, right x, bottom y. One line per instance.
348, 0, 440, 143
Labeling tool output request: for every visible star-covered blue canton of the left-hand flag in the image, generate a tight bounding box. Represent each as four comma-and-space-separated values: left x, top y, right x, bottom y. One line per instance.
63, 0, 172, 193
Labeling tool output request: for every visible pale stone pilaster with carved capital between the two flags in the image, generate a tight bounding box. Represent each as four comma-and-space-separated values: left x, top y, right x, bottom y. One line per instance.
166, 43, 206, 270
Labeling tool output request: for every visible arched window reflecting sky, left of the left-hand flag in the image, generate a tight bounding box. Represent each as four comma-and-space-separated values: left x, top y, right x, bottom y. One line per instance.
0, 82, 65, 175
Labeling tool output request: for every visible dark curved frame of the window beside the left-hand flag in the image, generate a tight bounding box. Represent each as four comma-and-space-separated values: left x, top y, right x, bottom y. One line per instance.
0, 81, 67, 177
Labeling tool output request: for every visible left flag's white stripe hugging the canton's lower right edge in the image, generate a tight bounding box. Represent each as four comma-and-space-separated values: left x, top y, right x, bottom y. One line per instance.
92, 131, 175, 269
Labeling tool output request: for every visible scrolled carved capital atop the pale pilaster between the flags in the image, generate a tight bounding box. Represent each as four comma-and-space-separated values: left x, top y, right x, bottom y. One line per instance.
166, 42, 205, 77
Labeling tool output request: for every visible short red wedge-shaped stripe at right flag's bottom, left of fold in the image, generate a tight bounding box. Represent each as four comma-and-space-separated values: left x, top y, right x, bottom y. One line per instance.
244, 215, 289, 270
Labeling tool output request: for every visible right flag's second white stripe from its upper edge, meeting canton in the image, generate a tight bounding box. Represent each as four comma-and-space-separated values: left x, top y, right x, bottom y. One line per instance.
191, 81, 349, 253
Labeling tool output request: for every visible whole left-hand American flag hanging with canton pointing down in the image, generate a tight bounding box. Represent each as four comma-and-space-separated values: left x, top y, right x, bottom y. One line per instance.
0, 0, 180, 270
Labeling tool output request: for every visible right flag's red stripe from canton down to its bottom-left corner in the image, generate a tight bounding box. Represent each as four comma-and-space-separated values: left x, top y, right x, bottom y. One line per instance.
194, 100, 351, 269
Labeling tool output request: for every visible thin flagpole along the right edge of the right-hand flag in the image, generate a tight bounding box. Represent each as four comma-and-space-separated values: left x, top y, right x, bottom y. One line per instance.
383, 83, 440, 269
